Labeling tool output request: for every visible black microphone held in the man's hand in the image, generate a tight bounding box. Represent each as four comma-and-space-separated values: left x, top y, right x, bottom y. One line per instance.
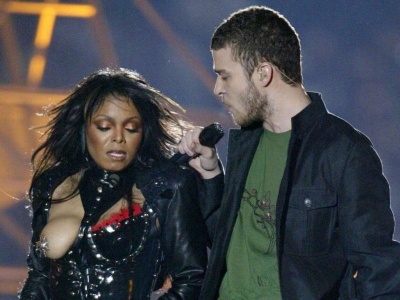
170, 122, 224, 164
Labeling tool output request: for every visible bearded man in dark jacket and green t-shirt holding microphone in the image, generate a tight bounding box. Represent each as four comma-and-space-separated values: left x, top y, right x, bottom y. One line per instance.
179, 7, 400, 300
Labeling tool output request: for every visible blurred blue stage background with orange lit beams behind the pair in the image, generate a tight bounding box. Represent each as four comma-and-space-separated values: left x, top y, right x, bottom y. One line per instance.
0, 0, 400, 300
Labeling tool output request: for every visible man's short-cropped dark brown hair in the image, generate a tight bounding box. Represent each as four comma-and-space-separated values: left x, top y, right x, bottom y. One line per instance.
211, 6, 303, 85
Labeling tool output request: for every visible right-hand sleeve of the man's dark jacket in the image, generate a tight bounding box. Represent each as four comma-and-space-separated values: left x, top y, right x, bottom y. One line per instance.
339, 139, 400, 299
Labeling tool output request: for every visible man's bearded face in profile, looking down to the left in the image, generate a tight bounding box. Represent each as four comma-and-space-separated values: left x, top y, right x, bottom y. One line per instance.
212, 47, 269, 127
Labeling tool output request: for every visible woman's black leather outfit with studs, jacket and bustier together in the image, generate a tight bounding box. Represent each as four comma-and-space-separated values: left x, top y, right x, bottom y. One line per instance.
20, 162, 208, 300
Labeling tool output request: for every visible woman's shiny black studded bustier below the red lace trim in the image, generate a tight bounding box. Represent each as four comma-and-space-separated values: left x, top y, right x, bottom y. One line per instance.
50, 206, 161, 300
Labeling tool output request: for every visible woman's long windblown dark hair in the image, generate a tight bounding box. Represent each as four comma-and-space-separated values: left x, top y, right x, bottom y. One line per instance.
31, 68, 190, 198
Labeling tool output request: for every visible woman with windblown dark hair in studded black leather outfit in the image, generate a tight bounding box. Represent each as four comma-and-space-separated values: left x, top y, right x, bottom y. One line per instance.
20, 69, 207, 300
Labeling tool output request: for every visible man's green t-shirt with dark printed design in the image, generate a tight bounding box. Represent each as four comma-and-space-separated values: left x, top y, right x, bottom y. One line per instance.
219, 130, 291, 300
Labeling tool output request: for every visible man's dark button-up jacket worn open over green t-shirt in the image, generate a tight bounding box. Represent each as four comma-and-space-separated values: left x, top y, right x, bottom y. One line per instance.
200, 93, 400, 300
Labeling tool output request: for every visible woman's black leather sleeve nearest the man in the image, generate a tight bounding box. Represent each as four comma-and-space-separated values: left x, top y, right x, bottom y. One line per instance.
159, 170, 208, 300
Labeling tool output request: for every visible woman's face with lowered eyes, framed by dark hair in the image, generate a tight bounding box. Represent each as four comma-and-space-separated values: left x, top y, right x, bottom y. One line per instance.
86, 95, 142, 171
